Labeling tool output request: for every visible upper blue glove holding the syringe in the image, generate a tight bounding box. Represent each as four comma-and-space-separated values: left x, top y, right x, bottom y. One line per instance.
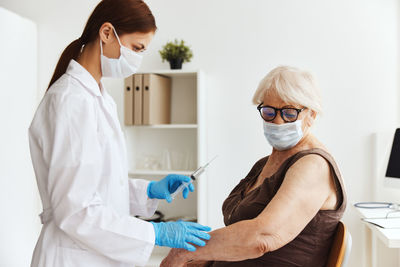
147, 174, 194, 203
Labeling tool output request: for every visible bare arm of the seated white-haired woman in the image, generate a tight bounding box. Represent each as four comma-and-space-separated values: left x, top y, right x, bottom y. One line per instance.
161, 155, 335, 266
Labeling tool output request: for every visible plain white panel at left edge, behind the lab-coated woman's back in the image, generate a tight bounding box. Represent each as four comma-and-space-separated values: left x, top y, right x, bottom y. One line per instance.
0, 7, 40, 267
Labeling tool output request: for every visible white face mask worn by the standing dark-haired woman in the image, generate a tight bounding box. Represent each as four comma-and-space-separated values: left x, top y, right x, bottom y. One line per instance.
100, 28, 142, 78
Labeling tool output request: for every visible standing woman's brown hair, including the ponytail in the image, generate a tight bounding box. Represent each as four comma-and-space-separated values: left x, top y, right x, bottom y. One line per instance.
47, 0, 157, 90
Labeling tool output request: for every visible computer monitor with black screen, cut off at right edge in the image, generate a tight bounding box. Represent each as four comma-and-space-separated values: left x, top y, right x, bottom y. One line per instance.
385, 128, 400, 188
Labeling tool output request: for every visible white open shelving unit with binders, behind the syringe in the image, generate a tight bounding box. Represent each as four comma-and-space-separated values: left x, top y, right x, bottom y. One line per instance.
124, 70, 207, 266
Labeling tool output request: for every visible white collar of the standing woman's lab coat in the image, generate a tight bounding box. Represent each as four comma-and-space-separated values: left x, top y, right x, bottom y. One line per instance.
66, 59, 104, 96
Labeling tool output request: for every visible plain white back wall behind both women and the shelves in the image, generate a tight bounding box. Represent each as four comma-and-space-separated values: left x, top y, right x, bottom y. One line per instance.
0, 0, 400, 267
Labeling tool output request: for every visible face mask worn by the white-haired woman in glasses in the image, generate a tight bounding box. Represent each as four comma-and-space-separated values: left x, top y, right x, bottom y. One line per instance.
263, 120, 303, 150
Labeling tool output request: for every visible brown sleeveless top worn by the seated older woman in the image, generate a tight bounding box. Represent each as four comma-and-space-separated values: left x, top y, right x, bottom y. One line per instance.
210, 148, 346, 267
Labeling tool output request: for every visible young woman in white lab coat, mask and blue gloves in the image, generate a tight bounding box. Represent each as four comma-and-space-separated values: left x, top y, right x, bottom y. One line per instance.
29, 0, 210, 267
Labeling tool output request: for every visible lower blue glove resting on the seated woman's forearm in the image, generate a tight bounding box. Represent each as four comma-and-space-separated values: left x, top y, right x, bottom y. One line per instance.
151, 221, 211, 251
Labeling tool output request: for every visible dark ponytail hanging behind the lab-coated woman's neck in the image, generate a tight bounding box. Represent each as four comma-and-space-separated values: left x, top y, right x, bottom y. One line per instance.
47, 38, 83, 90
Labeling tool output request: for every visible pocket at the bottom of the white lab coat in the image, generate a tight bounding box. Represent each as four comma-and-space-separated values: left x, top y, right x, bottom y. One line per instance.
57, 247, 112, 267
